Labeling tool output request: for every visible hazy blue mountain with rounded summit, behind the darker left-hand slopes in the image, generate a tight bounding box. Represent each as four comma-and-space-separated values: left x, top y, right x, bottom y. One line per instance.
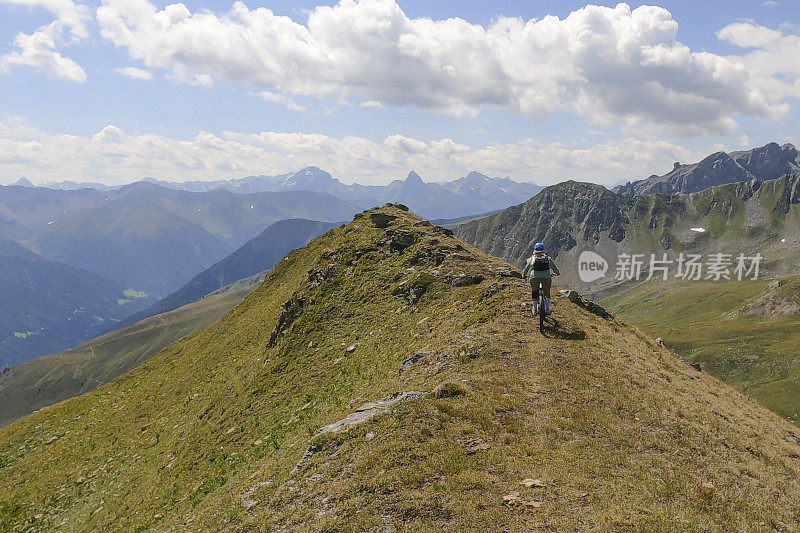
0, 182, 358, 301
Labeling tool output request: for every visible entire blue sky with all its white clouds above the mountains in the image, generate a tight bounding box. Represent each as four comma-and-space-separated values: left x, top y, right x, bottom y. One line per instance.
0, 0, 800, 184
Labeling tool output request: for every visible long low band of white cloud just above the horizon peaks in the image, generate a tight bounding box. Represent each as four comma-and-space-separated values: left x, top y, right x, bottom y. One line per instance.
0, 118, 703, 184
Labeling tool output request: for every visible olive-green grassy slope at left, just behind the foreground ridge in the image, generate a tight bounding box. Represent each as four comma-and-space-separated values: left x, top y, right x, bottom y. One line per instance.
0, 285, 255, 426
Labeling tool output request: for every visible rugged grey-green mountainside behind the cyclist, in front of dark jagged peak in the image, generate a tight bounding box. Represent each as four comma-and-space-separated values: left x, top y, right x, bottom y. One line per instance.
454, 174, 800, 294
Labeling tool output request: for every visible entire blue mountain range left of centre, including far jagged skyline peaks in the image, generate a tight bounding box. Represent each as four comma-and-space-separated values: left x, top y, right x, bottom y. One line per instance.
0, 167, 540, 365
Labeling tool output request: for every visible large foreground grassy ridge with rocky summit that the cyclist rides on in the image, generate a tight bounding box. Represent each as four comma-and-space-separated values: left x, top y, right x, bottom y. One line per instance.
0, 208, 800, 531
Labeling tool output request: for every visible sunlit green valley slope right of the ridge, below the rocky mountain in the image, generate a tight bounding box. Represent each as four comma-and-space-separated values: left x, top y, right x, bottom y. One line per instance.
604, 277, 800, 423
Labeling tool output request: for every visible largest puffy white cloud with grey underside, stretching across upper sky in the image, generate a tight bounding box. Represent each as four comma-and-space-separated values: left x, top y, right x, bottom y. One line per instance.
97, 0, 786, 135
